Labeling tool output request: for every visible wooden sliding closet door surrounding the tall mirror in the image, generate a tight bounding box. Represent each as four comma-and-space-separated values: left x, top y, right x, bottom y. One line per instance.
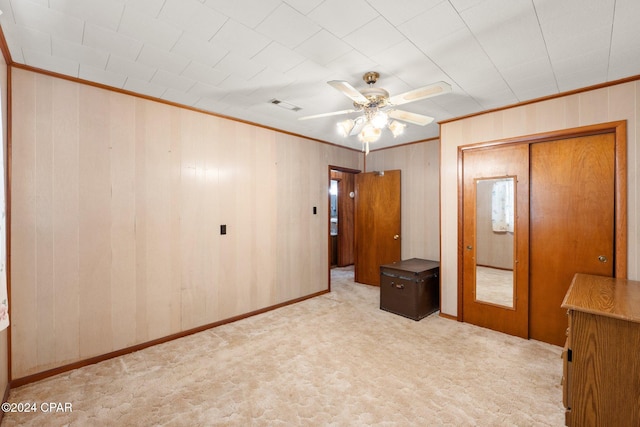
461, 144, 529, 338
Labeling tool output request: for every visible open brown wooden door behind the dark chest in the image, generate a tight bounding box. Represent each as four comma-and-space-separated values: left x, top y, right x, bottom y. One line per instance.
355, 170, 401, 286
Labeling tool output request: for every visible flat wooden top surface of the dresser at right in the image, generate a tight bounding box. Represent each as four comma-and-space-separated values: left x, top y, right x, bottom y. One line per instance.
562, 274, 640, 323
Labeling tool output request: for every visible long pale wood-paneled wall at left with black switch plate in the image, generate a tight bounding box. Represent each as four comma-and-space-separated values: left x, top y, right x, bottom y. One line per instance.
11, 69, 362, 379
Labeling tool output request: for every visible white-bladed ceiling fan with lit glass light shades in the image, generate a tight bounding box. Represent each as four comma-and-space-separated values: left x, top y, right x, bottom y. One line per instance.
298, 71, 451, 153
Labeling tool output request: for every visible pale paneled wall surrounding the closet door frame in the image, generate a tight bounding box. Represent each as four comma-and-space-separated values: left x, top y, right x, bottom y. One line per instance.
440, 81, 640, 316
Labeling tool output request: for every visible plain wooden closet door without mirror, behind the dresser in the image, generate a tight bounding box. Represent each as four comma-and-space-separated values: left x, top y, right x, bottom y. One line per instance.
529, 133, 615, 345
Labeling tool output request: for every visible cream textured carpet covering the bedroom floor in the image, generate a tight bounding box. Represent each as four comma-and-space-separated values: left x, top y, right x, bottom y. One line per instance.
2, 269, 564, 426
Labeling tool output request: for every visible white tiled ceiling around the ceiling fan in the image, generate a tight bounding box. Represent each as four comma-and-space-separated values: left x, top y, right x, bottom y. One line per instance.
0, 0, 640, 149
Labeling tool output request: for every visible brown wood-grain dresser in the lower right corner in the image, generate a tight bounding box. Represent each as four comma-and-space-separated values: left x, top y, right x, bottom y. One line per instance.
562, 274, 640, 427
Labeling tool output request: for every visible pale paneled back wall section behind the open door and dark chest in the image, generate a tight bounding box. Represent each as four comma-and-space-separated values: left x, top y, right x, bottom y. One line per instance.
366, 140, 440, 261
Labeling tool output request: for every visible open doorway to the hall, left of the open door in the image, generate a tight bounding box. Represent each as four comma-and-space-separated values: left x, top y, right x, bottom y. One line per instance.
329, 166, 360, 289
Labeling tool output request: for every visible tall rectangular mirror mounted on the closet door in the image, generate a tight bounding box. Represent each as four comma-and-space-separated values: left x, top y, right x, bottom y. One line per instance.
475, 177, 516, 308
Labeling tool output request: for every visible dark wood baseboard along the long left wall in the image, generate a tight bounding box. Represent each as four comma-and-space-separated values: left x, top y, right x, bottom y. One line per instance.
11, 289, 330, 392
